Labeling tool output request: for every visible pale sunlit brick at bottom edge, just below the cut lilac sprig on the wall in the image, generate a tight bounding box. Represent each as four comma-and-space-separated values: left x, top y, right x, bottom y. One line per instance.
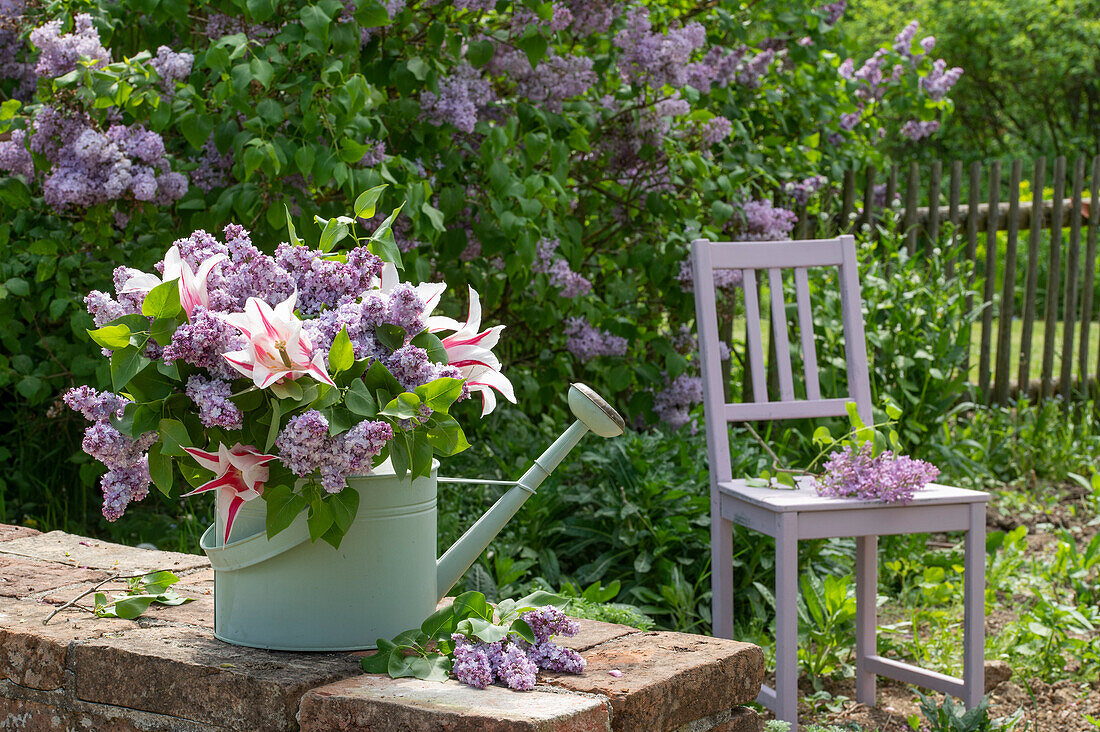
298, 675, 611, 732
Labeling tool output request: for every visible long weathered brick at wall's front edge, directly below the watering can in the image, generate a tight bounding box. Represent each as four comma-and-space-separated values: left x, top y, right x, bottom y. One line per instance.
69, 619, 362, 732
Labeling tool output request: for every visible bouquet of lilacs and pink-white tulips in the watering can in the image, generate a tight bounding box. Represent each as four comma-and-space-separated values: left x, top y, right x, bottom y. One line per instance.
64, 186, 516, 546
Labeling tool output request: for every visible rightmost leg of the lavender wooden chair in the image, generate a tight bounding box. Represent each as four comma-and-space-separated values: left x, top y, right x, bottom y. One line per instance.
963, 503, 986, 709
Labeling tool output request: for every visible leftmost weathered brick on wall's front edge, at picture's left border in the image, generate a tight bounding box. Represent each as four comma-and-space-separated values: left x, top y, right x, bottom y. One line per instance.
0, 600, 138, 686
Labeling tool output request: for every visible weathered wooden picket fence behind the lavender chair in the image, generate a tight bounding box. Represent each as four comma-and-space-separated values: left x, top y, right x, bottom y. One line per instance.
795, 156, 1100, 403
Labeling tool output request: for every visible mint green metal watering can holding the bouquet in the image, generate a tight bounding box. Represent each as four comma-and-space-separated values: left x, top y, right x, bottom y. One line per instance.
200, 384, 625, 651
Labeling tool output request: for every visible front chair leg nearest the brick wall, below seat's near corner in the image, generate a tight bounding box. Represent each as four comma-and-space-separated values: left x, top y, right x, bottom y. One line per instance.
774, 512, 799, 732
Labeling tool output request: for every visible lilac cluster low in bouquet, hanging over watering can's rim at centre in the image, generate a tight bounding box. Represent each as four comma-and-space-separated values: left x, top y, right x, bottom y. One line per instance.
275, 409, 394, 493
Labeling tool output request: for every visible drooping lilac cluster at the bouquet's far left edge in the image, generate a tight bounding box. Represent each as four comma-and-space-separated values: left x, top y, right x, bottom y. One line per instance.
63, 386, 157, 521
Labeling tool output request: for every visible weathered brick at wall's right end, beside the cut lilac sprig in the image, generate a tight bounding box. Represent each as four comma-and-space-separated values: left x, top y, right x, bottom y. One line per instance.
543, 632, 765, 731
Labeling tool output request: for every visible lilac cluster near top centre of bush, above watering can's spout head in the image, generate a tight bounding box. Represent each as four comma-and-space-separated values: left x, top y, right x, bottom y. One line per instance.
490, 46, 596, 112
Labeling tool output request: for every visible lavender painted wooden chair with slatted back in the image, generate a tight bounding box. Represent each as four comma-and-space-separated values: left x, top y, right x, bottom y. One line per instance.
692, 236, 989, 729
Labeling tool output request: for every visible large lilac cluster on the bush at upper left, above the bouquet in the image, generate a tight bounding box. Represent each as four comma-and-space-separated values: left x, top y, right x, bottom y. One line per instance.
31, 106, 187, 208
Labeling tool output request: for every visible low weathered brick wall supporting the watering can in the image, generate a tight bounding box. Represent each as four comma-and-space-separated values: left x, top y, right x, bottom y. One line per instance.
0, 525, 765, 732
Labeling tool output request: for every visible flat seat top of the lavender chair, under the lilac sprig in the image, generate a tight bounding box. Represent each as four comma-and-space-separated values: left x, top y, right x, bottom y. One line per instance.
718, 477, 989, 513
